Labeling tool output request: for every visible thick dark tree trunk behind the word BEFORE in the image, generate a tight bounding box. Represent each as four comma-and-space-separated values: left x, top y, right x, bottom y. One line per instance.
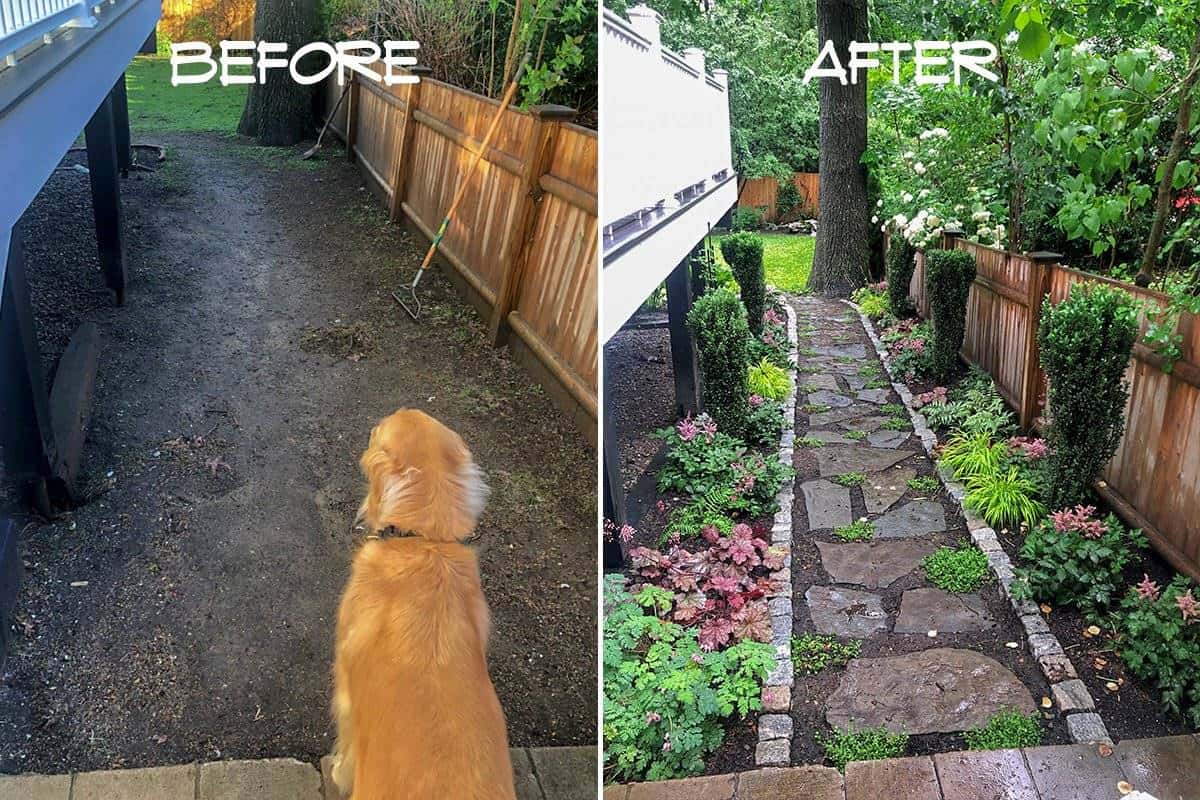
238, 0, 319, 146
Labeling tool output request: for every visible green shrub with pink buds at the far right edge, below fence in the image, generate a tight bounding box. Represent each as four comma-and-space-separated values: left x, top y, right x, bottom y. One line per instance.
1116, 576, 1200, 727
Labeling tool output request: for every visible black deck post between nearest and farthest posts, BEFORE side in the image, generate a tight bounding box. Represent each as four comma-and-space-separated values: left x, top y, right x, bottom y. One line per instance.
84, 92, 125, 305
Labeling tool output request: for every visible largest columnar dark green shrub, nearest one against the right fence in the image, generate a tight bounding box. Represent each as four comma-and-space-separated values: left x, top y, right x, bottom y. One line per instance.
1038, 283, 1138, 507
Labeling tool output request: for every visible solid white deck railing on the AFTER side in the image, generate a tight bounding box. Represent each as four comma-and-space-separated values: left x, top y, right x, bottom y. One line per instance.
600, 6, 732, 225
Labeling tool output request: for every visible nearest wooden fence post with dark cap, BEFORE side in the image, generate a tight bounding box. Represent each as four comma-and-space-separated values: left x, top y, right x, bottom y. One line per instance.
488, 106, 576, 347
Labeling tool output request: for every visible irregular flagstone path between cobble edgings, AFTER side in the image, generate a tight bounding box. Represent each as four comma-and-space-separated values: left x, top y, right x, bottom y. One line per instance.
782, 297, 1054, 758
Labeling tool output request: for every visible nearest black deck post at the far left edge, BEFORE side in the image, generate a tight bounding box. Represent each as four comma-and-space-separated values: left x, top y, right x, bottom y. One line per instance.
0, 227, 55, 513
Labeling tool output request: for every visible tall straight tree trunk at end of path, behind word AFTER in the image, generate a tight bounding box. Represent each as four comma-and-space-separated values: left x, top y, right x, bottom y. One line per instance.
809, 0, 870, 296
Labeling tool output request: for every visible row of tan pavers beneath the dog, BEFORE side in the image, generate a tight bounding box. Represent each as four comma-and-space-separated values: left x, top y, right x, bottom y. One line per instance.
0, 747, 596, 800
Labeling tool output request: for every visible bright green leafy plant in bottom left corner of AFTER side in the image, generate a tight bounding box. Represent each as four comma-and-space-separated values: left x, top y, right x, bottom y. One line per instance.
604, 577, 774, 781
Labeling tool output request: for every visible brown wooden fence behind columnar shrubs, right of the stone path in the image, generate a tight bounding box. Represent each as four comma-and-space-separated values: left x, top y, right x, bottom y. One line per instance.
908, 235, 1200, 579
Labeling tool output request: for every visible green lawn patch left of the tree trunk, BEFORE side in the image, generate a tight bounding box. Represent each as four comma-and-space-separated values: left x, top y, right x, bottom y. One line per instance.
125, 55, 246, 134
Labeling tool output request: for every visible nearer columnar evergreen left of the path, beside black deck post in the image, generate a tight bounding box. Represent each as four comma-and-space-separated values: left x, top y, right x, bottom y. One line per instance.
688, 288, 744, 437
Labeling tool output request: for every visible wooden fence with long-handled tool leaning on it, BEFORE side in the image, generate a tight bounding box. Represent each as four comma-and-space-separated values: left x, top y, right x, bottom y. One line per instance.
325, 67, 599, 439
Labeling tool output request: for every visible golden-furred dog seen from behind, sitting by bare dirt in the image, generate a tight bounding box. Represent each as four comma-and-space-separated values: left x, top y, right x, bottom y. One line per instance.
334, 409, 515, 800
